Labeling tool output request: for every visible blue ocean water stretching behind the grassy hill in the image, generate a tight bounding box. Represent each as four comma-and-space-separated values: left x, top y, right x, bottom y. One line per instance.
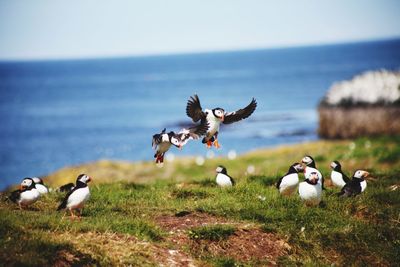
0, 40, 400, 189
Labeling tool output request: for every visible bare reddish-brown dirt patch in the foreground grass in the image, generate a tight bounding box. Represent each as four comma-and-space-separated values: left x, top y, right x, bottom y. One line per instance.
156, 213, 290, 265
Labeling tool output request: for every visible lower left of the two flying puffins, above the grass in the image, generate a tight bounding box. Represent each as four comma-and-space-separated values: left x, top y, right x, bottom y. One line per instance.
151, 122, 208, 163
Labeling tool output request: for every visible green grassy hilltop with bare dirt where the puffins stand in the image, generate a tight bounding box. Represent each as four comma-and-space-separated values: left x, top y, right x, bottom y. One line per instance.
0, 137, 400, 266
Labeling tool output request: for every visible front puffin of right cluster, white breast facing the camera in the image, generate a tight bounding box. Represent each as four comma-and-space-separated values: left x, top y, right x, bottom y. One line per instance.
299, 171, 322, 206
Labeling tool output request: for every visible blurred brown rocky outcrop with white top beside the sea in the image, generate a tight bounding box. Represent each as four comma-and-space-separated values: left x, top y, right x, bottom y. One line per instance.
318, 71, 400, 138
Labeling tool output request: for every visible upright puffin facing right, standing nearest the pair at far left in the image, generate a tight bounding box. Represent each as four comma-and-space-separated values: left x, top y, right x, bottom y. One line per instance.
57, 174, 92, 218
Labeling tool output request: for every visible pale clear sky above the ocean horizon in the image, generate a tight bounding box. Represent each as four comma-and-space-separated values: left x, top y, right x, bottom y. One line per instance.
0, 0, 400, 60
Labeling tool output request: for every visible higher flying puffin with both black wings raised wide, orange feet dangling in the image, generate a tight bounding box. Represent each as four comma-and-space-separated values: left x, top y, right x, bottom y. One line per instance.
186, 95, 257, 148
